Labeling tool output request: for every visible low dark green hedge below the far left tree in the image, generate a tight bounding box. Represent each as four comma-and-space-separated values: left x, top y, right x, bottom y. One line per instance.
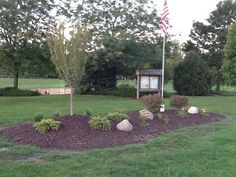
0, 87, 40, 96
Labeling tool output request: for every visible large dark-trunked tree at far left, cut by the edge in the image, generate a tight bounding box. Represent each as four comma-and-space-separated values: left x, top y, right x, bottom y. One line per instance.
0, 0, 54, 88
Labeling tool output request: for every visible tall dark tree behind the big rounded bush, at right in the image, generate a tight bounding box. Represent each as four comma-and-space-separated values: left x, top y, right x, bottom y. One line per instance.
188, 0, 236, 91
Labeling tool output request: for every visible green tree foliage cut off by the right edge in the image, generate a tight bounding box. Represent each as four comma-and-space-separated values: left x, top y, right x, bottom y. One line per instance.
222, 23, 236, 84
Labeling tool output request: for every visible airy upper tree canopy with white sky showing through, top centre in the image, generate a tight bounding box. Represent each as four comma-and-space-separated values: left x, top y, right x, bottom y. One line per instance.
75, 0, 160, 44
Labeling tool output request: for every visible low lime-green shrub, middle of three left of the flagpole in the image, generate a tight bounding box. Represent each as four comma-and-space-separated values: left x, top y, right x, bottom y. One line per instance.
88, 116, 111, 131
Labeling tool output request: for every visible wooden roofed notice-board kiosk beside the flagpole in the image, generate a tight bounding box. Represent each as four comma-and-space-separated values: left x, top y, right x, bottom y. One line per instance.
136, 69, 162, 99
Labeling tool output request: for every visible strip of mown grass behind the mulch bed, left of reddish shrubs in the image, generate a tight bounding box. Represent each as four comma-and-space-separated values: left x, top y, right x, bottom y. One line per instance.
0, 95, 142, 127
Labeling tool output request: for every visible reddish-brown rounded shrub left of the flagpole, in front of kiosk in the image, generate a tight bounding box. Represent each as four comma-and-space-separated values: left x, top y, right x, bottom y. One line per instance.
140, 94, 163, 112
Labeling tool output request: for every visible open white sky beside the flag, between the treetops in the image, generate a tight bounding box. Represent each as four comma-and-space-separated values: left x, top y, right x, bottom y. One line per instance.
153, 0, 221, 43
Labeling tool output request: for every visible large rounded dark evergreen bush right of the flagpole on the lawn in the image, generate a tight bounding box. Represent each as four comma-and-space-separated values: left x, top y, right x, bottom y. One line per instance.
173, 52, 211, 96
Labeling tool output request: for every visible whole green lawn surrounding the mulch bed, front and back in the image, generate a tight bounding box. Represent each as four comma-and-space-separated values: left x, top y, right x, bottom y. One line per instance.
0, 96, 236, 177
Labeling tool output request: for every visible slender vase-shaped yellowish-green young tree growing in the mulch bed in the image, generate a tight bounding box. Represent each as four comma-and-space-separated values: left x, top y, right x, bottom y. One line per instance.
48, 24, 89, 115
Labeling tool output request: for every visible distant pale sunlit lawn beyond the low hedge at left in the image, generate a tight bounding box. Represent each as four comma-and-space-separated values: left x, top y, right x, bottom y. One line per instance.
0, 78, 65, 89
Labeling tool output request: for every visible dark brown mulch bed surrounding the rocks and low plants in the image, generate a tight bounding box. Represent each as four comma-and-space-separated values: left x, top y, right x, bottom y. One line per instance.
0, 110, 224, 151
